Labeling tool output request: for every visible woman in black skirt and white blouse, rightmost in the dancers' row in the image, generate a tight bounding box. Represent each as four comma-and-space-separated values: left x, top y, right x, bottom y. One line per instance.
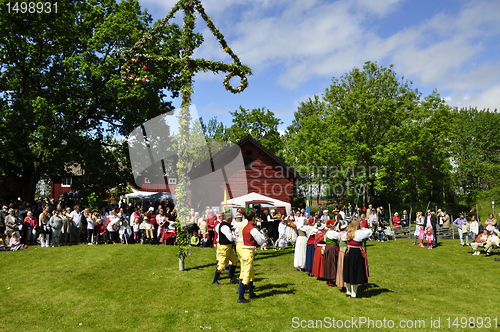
342, 219, 372, 298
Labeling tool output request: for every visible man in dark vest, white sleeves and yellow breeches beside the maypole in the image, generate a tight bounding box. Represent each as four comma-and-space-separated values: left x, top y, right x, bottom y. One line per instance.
212, 215, 238, 285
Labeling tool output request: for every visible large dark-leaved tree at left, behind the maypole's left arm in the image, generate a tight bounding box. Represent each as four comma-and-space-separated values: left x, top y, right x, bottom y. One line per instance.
0, 0, 184, 201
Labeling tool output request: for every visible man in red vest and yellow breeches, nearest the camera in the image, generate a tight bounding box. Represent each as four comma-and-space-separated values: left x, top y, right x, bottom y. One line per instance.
238, 209, 266, 303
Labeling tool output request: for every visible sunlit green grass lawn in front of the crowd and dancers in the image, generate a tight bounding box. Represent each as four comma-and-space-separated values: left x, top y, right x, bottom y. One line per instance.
0, 239, 500, 332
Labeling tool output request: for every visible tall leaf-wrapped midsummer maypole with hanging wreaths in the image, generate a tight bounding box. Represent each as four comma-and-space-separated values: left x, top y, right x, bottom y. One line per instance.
121, 0, 251, 271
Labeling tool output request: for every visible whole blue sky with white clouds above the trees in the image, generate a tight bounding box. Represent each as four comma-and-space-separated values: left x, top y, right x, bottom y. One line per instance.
139, 0, 500, 129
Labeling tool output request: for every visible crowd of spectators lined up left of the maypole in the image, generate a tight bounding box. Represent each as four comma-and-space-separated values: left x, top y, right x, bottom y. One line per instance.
0, 200, 186, 251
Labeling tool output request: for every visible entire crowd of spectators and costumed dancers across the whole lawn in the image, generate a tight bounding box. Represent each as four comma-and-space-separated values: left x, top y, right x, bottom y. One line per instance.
0, 196, 500, 303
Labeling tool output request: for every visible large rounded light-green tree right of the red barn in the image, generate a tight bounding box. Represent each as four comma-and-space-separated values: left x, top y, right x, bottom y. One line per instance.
287, 62, 450, 203
